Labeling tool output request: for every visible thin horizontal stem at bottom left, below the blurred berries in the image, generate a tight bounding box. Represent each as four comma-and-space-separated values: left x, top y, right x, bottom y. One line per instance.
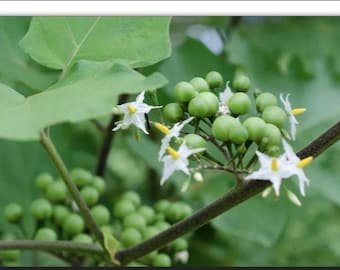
0, 240, 105, 255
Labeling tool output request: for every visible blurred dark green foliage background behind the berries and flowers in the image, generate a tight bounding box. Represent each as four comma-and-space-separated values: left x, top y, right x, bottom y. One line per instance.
0, 17, 340, 266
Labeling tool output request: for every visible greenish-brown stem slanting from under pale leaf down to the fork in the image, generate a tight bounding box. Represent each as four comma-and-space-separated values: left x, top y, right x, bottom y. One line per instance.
40, 132, 104, 247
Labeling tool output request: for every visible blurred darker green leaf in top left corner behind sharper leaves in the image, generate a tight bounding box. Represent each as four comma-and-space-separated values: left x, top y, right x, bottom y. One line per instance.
0, 17, 59, 95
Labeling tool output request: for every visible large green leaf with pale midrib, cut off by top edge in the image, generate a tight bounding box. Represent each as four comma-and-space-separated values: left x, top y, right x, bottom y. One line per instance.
21, 16, 170, 71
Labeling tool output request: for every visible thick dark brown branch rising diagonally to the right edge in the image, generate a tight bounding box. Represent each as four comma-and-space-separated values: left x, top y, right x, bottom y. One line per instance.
116, 121, 340, 264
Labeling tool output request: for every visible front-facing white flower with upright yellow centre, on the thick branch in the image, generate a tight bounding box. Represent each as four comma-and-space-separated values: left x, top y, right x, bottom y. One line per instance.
244, 151, 291, 196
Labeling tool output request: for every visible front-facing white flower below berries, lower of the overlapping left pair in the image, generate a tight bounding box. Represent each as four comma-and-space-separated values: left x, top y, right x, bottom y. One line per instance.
161, 141, 205, 185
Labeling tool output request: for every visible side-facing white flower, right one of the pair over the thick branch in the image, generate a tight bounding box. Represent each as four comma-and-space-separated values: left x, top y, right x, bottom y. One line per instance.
282, 140, 313, 196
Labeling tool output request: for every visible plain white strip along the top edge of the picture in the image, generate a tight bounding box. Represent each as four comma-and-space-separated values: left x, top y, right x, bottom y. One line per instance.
0, 1, 340, 16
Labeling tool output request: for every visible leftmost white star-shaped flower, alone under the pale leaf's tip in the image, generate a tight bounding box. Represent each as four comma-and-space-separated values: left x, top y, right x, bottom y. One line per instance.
112, 91, 161, 134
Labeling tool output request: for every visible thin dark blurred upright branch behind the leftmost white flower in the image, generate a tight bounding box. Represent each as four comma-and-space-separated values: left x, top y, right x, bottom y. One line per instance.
95, 95, 128, 176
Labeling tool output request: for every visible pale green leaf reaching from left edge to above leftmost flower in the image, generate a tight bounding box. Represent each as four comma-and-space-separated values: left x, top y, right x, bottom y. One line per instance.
0, 61, 167, 141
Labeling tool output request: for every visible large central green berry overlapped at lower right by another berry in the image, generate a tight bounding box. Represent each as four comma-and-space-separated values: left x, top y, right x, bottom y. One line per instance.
212, 115, 239, 141
